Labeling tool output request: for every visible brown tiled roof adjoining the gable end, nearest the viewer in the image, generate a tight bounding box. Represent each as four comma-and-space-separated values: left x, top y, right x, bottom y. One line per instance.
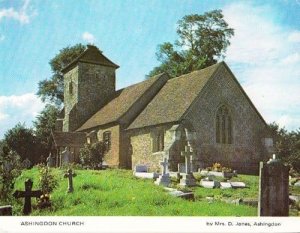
128, 63, 222, 129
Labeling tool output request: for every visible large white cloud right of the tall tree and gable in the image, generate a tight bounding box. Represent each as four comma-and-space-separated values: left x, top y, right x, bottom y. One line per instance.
223, 2, 300, 130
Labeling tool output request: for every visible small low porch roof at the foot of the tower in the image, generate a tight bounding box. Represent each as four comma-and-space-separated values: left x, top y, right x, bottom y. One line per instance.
52, 131, 86, 147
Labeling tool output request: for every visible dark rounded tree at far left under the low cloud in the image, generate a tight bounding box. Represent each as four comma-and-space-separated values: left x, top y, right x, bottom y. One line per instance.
4, 123, 41, 163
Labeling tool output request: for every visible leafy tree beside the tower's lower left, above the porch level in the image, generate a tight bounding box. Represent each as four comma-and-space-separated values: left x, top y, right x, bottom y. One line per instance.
33, 104, 59, 155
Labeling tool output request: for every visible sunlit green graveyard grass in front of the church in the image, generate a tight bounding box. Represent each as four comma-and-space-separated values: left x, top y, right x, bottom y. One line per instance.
1, 161, 300, 216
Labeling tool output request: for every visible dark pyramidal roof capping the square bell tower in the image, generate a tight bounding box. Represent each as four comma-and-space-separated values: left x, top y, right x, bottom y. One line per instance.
61, 45, 119, 73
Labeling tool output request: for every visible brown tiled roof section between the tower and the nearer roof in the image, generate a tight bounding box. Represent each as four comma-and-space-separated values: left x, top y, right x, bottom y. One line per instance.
77, 74, 164, 131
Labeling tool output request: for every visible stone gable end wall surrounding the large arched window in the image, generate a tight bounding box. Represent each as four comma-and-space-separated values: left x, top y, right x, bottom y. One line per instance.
186, 64, 267, 173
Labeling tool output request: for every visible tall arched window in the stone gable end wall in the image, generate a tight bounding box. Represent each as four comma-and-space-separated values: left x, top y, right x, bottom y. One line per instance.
216, 105, 232, 144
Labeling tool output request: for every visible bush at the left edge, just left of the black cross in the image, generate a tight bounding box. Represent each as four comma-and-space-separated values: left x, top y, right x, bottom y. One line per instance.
0, 146, 21, 204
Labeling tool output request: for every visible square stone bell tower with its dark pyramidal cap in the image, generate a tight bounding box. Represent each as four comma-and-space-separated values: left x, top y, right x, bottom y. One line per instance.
62, 45, 119, 132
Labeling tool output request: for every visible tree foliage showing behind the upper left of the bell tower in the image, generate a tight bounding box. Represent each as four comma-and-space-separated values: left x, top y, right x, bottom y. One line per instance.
37, 44, 85, 107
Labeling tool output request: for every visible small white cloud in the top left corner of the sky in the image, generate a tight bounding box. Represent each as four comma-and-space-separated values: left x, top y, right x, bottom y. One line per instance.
0, 0, 37, 24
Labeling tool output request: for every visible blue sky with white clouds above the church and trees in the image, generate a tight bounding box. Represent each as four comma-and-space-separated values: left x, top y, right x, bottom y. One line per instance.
0, 0, 300, 139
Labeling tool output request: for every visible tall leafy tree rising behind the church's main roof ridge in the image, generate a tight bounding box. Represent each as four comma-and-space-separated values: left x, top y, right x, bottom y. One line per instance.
147, 10, 234, 77
